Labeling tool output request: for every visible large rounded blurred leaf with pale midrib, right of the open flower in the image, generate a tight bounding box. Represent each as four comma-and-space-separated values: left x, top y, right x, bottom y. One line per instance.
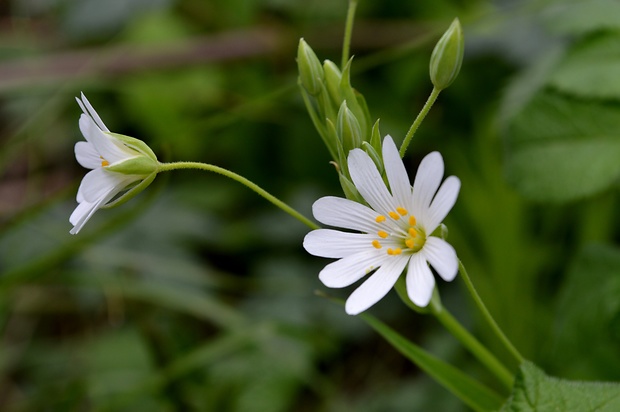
506, 92, 620, 203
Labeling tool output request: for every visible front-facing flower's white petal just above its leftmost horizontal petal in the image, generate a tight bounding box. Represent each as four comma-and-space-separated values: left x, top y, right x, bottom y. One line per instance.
312, 196, 381, 233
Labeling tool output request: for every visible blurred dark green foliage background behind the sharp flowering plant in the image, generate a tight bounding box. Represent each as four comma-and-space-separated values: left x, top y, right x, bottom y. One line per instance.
0, 0, 620, 412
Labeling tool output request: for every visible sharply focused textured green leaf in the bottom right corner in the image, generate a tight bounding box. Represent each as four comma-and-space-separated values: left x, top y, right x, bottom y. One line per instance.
500, 361, 620, 412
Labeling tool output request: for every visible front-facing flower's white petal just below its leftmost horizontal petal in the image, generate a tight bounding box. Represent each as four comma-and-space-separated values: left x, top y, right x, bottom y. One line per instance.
319, 249, 390, 288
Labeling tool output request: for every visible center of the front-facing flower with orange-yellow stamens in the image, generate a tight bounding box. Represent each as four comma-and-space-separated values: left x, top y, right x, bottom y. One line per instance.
372, 206, 426, 256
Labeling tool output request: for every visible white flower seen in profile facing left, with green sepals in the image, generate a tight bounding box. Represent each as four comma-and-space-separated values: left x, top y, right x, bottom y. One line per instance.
69, 93, 158, 234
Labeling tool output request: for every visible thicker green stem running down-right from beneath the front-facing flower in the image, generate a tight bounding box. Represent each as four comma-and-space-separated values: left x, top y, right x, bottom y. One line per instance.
431, 300, 514, 392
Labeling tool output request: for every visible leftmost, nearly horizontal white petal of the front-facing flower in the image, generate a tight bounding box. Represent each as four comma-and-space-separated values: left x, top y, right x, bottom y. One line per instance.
304, 229, 377, 258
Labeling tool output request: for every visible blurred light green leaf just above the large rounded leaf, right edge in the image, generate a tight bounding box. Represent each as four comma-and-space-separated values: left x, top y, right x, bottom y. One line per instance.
549, 32, 620, 99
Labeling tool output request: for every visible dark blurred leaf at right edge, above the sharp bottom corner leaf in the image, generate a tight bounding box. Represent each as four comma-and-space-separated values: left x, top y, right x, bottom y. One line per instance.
549, 245, 620, 380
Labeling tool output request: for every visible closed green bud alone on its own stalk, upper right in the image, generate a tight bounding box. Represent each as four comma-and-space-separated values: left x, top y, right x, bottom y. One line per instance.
430, 18, 465, 90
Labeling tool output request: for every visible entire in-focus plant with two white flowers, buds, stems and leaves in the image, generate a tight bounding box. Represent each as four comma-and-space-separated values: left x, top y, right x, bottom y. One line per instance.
69, 0, 620, 411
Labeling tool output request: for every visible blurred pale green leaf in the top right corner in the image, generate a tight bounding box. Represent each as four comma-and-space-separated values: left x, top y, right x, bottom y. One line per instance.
541, 0, 620, 35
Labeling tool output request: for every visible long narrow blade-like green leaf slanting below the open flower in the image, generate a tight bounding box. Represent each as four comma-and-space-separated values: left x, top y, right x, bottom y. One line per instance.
360, 314, 503, 411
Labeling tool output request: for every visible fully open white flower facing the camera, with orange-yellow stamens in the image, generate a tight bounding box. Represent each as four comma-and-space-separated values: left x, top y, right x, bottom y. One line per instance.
304, 135, 461, 315
